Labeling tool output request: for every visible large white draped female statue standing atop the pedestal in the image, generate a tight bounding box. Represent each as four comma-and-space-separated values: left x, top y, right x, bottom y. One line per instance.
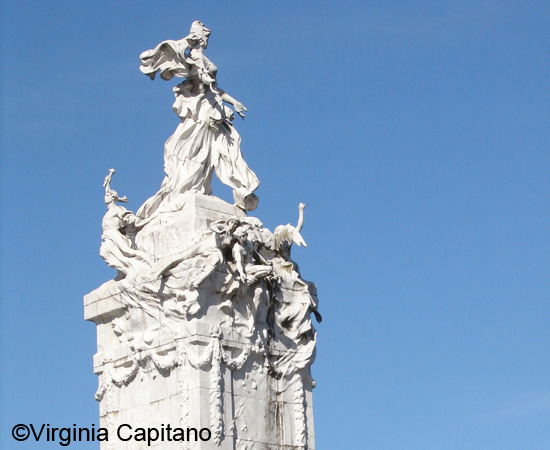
137, 21, 260, 223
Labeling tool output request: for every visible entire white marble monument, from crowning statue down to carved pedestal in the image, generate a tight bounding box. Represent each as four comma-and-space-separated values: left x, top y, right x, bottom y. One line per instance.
84, 22, 321, 450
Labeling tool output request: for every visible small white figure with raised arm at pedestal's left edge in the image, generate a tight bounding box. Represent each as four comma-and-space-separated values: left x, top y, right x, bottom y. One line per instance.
99, 169, 149, 279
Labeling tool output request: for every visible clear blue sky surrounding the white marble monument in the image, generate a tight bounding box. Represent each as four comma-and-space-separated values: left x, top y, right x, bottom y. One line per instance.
0, 0, 550, 450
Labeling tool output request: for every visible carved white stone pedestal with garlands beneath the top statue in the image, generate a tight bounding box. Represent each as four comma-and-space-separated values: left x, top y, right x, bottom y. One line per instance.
84, 193, 317, 450
